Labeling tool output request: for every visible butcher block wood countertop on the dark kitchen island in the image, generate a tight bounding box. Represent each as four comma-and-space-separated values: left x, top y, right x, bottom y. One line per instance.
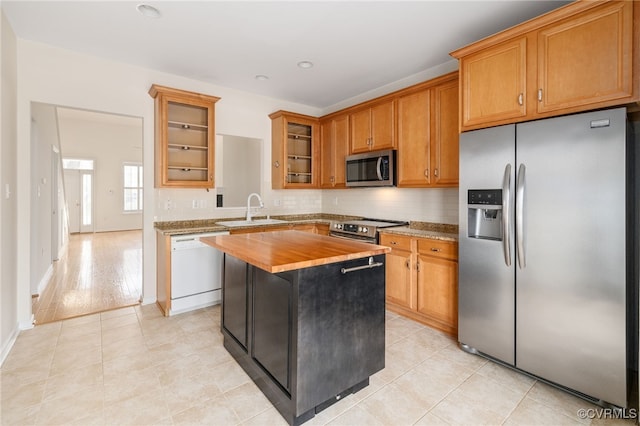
200, 231, 391, 273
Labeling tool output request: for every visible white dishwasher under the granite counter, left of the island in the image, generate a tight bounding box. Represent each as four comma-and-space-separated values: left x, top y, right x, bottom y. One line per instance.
170, 231, 229, 314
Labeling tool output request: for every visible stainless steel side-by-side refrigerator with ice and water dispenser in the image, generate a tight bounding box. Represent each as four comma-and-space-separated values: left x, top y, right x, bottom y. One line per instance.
458, 108, 637, 407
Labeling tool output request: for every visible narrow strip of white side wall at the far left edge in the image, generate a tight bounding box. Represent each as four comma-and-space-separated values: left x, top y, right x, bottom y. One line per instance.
0, 10, 19, 365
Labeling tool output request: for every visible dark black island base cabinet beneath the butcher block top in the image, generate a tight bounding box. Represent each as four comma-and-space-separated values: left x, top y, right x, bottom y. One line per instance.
221, 254, 385, 425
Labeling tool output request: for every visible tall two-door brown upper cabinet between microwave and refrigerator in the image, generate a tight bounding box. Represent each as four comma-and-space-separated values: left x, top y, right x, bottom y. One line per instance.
397, 72, 458, 187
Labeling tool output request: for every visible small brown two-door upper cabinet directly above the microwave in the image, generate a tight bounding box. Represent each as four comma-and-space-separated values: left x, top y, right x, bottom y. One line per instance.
349, 99, 396, 154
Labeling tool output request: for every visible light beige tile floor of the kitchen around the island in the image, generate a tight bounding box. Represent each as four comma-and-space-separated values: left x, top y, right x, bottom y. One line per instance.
0, 305, 632, 426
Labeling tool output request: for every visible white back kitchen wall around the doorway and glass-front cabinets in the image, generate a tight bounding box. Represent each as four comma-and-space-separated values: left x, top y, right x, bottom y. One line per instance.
13, 37, 322, 322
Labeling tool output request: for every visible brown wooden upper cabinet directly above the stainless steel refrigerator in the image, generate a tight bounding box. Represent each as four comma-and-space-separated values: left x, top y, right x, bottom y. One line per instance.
451, 1, 640, 131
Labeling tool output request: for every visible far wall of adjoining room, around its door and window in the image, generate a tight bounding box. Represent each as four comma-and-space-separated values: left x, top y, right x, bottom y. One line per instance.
58, 108, 142, 232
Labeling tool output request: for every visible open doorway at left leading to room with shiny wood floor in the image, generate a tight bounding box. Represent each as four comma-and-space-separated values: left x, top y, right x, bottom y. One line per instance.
30, 102, 143, 324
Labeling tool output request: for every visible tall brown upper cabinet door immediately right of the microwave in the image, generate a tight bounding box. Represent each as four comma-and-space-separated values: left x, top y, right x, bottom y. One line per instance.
398, 88, 432, 186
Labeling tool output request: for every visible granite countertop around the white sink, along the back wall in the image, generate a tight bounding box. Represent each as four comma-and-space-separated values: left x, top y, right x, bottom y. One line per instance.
154, 213, 359, 235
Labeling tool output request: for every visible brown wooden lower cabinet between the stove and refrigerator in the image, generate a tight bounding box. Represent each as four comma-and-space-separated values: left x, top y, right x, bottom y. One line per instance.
380, 233, 458, 335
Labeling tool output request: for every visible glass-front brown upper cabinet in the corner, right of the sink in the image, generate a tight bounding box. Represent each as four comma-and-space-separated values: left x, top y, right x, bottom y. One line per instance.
269, 111, 320, 189
